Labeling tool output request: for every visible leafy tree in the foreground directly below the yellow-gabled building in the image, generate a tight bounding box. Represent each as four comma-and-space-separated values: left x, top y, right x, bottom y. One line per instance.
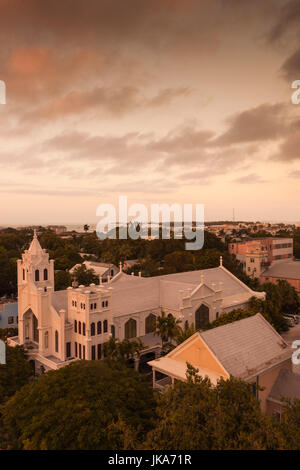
145, 368, 282, 450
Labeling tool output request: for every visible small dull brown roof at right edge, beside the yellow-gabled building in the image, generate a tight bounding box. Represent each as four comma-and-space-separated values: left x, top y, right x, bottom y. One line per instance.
268, 369, 300, 402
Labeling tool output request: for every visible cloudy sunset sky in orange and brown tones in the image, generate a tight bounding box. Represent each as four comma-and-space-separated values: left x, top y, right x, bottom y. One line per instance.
0, 0, 300, 225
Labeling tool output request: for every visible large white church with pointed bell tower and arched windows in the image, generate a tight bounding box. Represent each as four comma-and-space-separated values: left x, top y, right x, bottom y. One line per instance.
8, 233, 265, 370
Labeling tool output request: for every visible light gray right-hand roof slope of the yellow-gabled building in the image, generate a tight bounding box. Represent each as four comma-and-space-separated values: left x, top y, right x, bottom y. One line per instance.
199, 313, 292, 379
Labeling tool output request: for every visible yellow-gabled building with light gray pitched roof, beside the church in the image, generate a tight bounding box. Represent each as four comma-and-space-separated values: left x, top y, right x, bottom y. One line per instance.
149, 313, 294, 412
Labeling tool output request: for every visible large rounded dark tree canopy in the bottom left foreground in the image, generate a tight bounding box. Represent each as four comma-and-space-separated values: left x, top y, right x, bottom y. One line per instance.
2, 360, 155, 450
